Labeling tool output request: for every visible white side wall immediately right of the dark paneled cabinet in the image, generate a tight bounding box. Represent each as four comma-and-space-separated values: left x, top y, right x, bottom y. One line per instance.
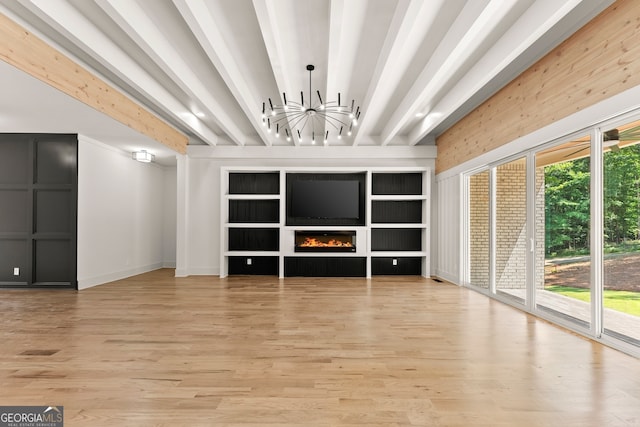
78, 135, 176, 289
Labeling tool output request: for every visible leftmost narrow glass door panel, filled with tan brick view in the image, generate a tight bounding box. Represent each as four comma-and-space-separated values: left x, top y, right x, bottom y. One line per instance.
469, 171, 491, 289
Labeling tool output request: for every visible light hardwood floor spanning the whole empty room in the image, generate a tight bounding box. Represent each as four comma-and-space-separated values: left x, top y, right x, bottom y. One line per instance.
0, 270, 640, 427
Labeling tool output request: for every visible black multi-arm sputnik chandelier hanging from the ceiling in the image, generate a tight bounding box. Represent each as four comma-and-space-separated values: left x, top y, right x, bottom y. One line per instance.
262, 65, 360, 144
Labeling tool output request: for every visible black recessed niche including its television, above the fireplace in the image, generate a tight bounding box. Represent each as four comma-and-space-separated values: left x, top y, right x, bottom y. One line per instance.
286, 173, 366, 225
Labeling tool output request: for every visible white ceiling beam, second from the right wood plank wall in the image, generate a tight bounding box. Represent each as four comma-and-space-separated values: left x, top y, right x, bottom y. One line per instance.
381, 0, 530, 145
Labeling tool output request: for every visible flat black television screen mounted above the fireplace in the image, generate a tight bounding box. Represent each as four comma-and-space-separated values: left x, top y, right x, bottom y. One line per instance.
290, 180, 360, 219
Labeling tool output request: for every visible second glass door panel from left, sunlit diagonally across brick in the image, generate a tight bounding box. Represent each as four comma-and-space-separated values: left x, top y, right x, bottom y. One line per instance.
495, 157, 529, 303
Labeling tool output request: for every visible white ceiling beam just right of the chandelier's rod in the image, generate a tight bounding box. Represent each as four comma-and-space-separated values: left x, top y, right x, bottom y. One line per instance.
325, 0, 367, 143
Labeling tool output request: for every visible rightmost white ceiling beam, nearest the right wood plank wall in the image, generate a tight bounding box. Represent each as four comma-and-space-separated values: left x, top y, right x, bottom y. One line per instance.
409, 0, 613, 145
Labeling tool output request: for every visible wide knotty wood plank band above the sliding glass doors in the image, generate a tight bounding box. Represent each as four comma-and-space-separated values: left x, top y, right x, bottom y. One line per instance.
436, 0, 640, 173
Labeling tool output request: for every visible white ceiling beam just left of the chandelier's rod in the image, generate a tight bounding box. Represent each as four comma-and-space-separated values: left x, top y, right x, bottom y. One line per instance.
253, 0, 306, 146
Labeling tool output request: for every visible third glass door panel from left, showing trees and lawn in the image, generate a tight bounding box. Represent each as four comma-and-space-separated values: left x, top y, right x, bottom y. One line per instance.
535, 135, 591, 328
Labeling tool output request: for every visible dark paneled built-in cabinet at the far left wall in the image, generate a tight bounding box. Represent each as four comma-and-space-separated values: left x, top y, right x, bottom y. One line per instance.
0, 134, 78, 288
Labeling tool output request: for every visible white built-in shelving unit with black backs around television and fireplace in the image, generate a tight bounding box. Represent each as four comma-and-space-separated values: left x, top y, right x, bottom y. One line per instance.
220, 167, 430, 277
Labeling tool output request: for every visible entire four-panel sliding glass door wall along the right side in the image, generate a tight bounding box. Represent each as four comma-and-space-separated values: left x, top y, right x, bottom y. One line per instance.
466, 120, 640, 354
